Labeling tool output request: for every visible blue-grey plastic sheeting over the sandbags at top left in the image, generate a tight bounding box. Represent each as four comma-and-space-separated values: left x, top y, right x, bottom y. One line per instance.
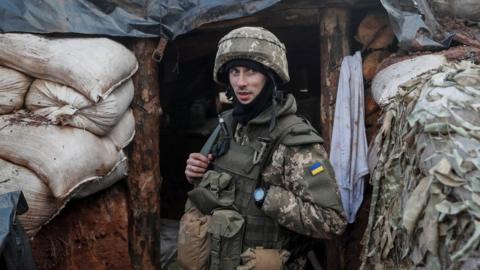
0, 0, 280, 39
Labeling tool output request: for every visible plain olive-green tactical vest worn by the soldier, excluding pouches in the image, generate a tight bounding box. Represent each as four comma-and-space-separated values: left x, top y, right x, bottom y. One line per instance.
210, 108, 322, 269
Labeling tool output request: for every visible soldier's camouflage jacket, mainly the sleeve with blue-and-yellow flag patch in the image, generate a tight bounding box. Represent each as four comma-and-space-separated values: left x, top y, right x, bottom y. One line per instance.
234, 95, 346, 238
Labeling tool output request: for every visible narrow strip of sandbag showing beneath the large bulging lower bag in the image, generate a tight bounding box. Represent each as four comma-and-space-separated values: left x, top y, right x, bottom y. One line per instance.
73, 152, 128, 199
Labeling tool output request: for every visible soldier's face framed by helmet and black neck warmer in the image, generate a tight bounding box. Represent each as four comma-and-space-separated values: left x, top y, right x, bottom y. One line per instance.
228, 66, 267, 104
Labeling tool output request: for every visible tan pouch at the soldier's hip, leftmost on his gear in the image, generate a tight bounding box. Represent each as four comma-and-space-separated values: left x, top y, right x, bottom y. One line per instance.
177, 207, 211, 270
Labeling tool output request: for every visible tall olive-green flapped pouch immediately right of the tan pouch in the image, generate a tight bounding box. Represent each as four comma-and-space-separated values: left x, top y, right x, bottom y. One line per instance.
208, 209, 245, 270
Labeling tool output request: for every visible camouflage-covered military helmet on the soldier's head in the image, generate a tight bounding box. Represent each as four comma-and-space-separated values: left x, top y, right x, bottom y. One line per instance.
213, 27, 290, 84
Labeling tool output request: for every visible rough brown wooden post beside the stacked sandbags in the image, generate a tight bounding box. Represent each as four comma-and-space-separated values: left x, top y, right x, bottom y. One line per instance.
128, 39, 162, 270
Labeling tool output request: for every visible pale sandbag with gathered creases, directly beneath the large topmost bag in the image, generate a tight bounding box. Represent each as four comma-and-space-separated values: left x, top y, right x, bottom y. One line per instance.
25, 80, 134, 136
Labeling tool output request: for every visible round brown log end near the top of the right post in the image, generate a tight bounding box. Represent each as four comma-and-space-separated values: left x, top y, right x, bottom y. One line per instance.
355, 12, 395, 49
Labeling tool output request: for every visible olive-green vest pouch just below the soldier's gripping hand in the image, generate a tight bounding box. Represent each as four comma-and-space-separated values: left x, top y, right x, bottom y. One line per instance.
188, 170, 235, 215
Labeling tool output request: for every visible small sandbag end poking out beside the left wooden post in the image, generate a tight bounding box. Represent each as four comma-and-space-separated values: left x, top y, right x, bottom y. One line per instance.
107, 109, 135, 150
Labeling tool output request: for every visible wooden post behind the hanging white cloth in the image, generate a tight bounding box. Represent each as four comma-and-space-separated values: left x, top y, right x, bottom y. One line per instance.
320, 8, 350, 152
